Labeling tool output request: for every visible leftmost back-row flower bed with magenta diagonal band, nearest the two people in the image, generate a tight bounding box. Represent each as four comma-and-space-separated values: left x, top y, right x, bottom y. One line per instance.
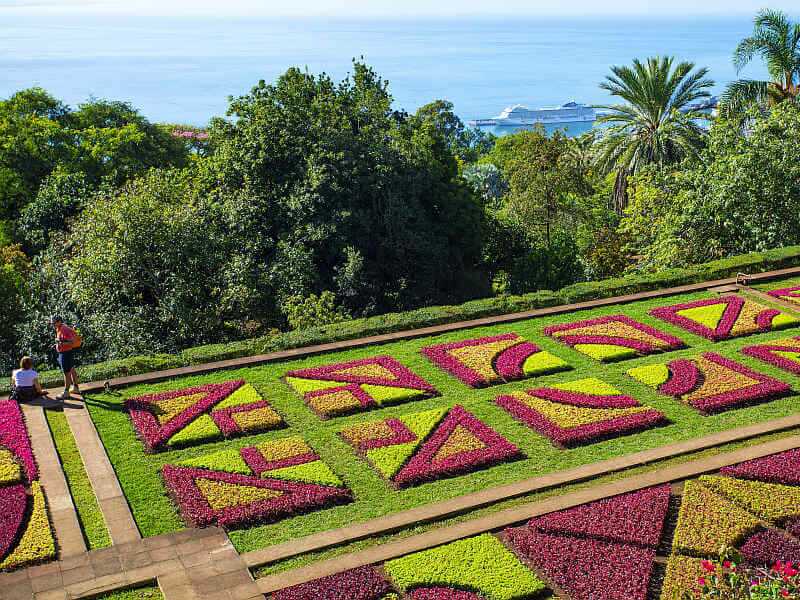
125, 380, 283, 452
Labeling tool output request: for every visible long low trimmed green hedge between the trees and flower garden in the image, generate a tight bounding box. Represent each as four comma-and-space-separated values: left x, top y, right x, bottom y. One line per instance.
7, 246, 800, 393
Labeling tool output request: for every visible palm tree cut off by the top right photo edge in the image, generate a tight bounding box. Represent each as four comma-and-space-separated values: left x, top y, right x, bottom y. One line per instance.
720, 10, 800, 115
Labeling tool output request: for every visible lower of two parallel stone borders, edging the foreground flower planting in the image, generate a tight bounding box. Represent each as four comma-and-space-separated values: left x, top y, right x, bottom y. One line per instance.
256, 435, 800, 593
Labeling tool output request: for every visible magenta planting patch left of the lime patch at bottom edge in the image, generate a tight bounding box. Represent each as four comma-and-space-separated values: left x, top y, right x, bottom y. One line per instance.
272, 567, 392, 600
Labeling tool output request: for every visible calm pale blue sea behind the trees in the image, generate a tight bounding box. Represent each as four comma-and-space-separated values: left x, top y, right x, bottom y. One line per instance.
0, 9, 776, 135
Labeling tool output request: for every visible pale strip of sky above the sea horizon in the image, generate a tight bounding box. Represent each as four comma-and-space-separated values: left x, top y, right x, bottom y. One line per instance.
0, 0, 797, 17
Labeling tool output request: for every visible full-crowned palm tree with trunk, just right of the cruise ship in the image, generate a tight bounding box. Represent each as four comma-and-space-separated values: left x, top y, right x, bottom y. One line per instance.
597, 57, 714, 214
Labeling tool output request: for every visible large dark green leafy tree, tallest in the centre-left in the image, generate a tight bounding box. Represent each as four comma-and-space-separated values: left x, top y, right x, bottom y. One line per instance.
207, 62, 481, 314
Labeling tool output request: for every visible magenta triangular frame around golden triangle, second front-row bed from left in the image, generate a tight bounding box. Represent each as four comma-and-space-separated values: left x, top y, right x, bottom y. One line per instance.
394, 405, 523, 486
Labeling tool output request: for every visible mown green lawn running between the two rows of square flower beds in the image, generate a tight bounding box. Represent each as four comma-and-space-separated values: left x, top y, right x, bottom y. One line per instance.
83, 294, 800, 552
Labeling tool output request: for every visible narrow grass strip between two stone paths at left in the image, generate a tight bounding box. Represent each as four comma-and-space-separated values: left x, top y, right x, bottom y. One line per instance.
44, 409, 111, 550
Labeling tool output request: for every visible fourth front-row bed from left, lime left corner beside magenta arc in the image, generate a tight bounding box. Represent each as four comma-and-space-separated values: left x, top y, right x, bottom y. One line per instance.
628, 352, 791, 414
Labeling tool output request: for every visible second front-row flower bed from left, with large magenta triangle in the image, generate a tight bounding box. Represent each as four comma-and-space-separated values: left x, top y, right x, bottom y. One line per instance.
339, 405, 522, 487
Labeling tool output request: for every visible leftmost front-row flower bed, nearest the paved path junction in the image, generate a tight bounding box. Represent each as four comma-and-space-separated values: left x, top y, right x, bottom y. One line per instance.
162, 437, 352, 528
